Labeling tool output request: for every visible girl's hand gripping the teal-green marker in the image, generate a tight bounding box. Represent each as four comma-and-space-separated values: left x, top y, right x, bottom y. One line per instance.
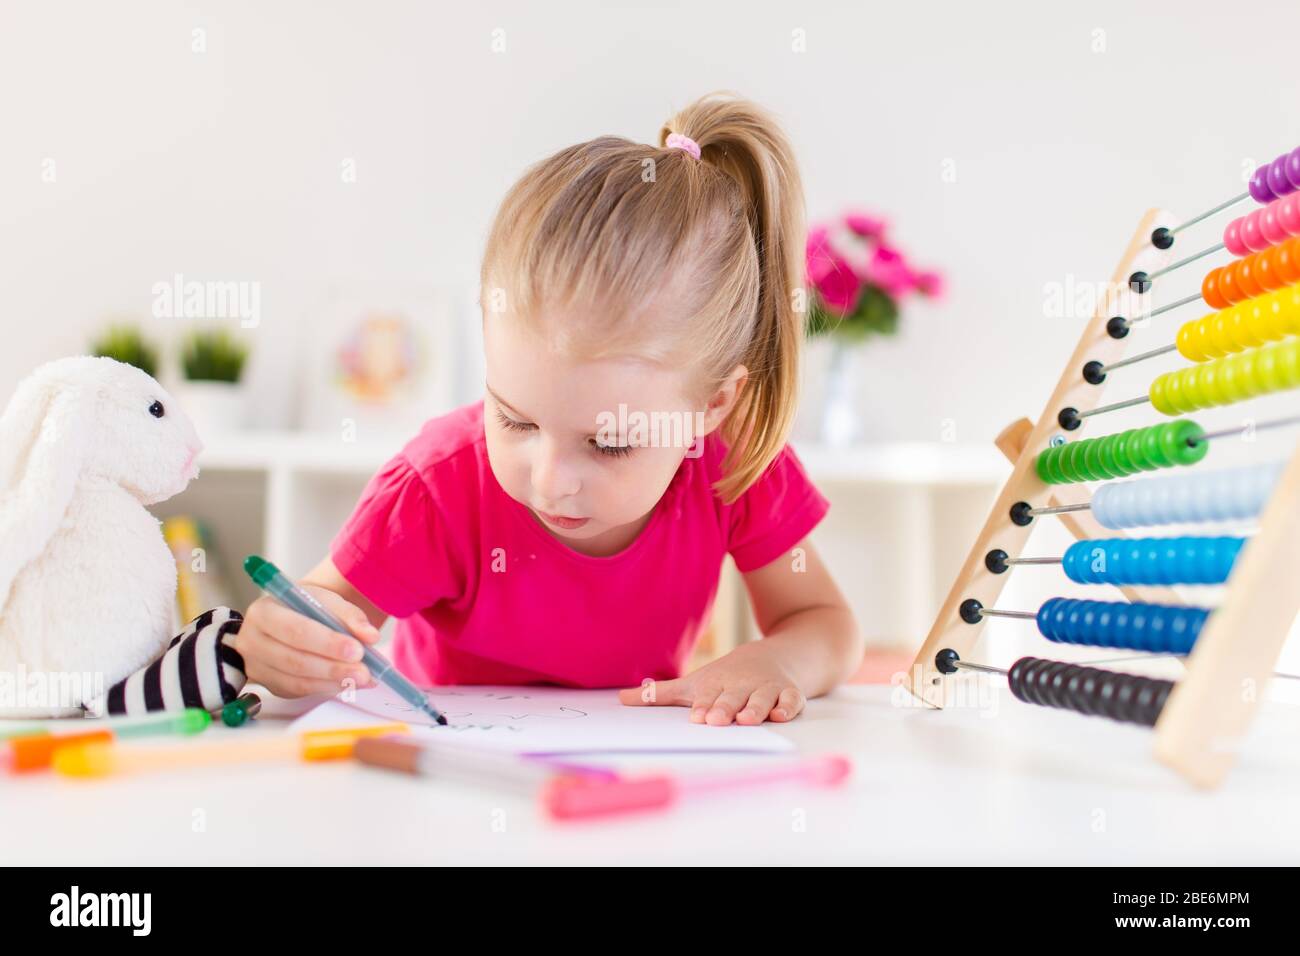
235, 584, 380, 697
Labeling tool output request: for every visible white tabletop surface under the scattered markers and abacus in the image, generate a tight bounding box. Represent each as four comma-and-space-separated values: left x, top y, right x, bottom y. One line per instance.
10, 678, 1300, 865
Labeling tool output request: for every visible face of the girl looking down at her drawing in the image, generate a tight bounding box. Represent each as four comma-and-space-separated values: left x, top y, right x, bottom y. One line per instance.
484, 315, 735, 555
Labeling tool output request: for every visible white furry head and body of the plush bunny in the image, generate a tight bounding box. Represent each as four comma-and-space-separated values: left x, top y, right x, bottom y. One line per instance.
0, 356, 202, 717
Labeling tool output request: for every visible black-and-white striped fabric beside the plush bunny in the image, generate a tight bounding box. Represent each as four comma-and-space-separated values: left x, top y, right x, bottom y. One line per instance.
100, 607, 247, 717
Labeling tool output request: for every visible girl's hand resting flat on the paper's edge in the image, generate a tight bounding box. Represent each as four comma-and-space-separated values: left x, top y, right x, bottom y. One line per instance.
619, 641, 806, 727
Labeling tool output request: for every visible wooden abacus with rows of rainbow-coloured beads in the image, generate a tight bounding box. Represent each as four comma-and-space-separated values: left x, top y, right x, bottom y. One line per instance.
909, 147, 1300, 787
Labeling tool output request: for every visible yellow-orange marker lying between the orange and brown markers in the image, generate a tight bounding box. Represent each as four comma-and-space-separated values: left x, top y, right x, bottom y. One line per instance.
53, 723, 410, 777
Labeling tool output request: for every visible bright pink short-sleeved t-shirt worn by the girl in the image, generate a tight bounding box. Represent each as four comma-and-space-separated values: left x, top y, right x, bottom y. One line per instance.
330, 401, 829, 687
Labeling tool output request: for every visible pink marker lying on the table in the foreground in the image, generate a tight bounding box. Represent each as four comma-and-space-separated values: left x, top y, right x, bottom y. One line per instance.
541, 754, 853, 819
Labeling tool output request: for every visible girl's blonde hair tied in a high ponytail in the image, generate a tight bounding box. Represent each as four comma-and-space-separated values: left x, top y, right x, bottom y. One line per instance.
481, 92, 806, 503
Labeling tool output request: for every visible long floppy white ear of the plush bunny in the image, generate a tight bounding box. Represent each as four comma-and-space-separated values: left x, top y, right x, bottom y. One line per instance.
0, 368, 90, 609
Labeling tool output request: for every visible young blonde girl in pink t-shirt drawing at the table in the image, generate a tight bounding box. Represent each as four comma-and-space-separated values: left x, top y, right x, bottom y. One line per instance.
237, 95, 863, 724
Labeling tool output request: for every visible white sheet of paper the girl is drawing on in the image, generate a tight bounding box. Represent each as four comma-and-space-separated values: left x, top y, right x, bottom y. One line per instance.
289, 687, 794, 754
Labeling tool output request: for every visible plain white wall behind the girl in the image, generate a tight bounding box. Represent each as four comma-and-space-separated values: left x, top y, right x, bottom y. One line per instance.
0, 0, 1300, 441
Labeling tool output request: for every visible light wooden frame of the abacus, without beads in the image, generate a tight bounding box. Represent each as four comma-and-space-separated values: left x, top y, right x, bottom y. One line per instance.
909, 209, 1300, 787
